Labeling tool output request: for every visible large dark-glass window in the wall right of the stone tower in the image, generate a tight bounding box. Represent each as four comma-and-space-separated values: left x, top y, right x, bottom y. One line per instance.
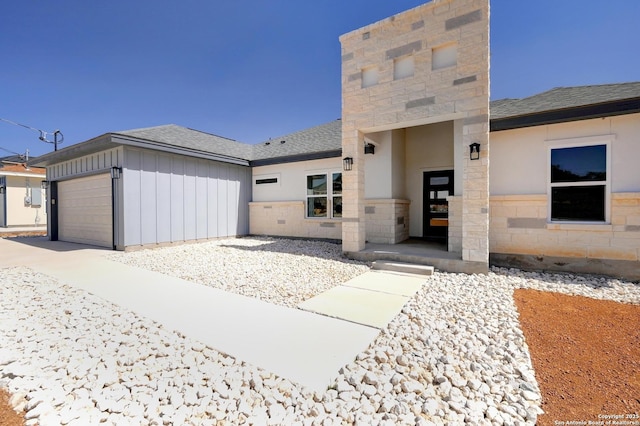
549, 143, 611, 223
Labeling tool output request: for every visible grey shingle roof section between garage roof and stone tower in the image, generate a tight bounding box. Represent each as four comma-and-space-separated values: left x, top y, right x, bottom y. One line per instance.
252, 119, 342, 160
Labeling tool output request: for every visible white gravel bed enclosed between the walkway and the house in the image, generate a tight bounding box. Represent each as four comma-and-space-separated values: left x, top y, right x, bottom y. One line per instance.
109, 238, 369, 308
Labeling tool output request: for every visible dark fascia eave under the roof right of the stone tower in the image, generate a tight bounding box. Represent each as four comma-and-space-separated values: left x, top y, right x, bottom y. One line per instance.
490, 98, 640, 132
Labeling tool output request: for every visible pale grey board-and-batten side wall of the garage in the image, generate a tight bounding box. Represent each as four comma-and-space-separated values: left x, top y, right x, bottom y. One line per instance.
122, 148, 251, 247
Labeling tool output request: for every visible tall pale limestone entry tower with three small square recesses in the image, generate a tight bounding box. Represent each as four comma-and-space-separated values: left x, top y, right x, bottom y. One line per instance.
340, 0, 489, 265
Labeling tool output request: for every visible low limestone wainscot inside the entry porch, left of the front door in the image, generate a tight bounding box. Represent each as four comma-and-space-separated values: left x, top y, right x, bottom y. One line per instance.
364, 199, 411, 244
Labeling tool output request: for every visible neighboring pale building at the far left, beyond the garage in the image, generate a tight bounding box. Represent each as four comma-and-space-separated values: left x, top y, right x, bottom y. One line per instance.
0, 160, 47, 228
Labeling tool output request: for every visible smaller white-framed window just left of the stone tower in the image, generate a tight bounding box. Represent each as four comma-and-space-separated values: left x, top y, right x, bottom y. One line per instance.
307, 172, 342, 218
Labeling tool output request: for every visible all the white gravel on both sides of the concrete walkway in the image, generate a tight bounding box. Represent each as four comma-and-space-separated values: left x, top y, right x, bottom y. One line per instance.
0, 238, 640, 426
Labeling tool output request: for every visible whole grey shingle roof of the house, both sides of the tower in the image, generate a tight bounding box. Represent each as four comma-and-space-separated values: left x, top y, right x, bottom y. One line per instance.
32, 82, 640, 169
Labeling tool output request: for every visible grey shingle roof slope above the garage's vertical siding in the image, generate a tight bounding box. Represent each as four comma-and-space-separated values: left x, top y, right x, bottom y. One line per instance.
112, 124, 252, 160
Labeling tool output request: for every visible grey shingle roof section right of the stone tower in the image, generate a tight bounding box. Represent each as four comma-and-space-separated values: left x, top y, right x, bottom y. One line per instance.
491, 82, 640, 120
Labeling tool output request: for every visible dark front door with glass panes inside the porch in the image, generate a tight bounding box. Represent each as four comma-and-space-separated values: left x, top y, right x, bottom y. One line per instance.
422, 170, 453, 240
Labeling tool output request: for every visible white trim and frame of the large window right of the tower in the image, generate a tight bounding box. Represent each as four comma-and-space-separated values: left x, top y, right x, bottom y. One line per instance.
545, 134, 615, 225
